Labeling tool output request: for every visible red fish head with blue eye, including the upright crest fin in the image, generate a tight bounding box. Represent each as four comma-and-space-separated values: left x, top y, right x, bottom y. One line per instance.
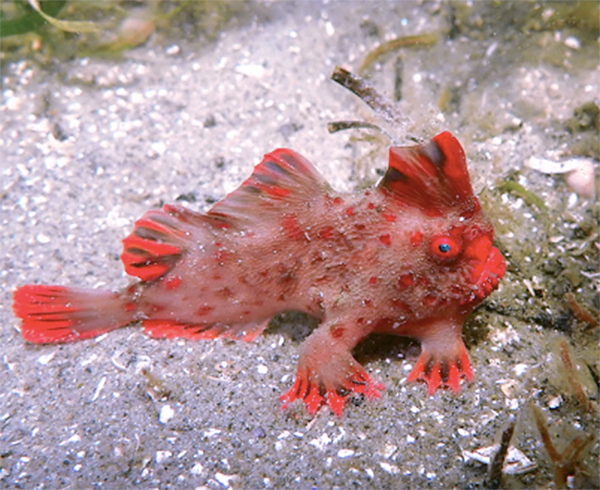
379, 132, 506, 306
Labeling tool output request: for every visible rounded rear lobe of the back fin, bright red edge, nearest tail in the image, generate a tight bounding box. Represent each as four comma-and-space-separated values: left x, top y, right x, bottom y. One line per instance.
121, 204, 206, 281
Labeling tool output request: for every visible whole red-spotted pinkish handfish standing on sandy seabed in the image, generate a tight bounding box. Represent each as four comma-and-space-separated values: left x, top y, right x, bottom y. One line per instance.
13, 132, 505, 415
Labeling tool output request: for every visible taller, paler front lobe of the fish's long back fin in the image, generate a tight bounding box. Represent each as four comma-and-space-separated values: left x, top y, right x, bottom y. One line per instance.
207, 148, 329, 225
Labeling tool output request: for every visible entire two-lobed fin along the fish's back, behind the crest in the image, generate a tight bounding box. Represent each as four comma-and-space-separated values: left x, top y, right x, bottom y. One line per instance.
121, 149, 329, 281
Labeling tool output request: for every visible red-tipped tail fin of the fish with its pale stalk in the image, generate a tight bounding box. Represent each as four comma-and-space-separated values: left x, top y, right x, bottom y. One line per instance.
13, 285, 134, 344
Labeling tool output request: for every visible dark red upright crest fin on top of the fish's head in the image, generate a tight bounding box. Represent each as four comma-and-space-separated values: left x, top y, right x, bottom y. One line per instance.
379, 132, 479, 217
